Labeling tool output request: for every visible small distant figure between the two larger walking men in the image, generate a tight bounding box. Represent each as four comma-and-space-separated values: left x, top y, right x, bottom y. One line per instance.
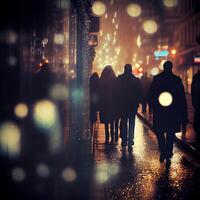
140, 72, 151, 113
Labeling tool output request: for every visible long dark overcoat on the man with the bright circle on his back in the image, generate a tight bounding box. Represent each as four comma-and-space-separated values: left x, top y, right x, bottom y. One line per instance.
149, 71, 187, 133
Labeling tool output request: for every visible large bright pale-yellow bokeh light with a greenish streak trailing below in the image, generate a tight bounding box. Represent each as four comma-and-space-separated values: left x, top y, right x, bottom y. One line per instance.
33, 100, 57, 130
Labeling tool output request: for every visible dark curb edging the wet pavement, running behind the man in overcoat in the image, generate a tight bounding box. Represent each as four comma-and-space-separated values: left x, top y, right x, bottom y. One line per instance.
137, 113, 200, 159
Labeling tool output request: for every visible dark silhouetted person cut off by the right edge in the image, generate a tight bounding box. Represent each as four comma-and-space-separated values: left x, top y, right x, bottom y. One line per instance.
191, 71, 200, 143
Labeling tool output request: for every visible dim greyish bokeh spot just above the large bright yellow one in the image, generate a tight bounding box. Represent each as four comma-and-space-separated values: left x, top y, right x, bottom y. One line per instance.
50, 83, 69, 100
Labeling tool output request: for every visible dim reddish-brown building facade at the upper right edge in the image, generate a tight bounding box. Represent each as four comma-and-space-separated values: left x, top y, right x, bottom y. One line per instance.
174, 0, 200, 93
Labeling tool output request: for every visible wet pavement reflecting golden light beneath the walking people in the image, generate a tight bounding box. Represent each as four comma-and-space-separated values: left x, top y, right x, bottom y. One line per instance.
94, 118, 200, 200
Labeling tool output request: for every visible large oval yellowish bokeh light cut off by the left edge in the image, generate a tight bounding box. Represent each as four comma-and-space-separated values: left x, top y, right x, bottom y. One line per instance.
0, 121, 21, 157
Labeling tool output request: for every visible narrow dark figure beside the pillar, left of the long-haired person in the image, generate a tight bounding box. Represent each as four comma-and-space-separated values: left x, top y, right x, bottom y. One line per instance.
90, 72, 99, 133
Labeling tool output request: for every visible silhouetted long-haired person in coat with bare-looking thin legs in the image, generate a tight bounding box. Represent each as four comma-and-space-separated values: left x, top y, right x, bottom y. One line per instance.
99, 65, 116, 144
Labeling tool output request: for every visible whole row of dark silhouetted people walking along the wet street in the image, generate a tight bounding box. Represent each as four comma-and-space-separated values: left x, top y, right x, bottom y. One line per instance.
90, 61, 200, 166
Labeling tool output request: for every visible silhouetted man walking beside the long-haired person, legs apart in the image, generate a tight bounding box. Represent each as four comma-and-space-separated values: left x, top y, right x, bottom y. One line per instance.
117, 64, 141, 150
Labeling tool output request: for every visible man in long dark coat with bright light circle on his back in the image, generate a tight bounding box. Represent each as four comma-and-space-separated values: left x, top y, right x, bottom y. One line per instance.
149, 61, 188, 167
